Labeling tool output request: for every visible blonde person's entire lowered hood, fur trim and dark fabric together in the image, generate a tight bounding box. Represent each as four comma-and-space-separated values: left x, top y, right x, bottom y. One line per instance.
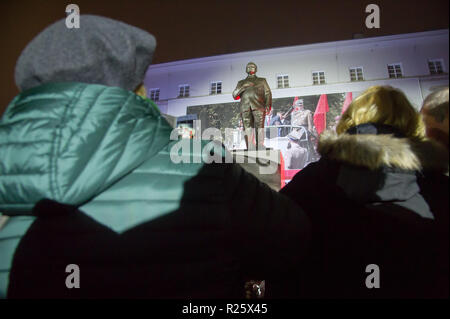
318, 131, 448, 219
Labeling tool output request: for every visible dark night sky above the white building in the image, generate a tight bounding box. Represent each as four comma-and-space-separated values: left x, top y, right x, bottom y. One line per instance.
0, 0, 449, 114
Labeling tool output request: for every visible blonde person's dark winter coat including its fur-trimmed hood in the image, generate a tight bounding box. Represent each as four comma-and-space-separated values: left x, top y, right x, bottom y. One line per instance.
280, 127, 449, 298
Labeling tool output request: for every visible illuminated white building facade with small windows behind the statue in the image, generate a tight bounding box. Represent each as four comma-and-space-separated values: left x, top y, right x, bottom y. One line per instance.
144, 29, 449, 117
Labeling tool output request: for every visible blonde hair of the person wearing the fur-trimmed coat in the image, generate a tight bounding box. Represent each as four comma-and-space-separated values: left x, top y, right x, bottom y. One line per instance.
336, 86, 425, 139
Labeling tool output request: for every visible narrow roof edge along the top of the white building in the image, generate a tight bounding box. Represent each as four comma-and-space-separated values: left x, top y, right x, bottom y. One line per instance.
149, 29, 449, 71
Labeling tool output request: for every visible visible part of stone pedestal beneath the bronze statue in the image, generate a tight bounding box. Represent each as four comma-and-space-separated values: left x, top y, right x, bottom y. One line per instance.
231, 149, 281, 191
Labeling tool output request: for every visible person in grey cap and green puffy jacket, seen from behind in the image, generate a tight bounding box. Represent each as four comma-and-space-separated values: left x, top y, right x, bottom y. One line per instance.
0, 15, 311, 298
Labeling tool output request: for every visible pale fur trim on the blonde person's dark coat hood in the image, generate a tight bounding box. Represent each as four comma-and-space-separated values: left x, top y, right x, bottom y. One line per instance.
318, 131, 449, 173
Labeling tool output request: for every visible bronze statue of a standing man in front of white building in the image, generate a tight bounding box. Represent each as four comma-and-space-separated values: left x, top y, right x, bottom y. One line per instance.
233, 62, 272, 149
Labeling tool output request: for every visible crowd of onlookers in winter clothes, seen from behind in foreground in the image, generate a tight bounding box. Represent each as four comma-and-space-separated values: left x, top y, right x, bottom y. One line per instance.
0, 15, 449, 299
